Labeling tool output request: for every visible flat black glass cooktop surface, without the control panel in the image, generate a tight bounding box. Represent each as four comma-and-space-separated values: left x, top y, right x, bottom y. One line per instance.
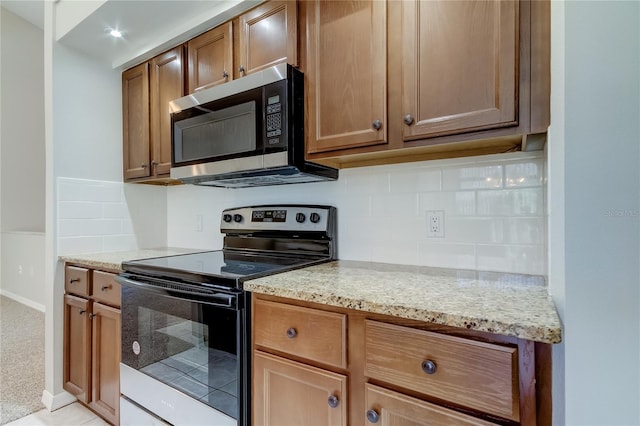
122, 250, 322, 286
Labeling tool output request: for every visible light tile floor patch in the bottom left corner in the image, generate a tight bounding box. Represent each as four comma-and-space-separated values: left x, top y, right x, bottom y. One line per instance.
6, 402, 109, 426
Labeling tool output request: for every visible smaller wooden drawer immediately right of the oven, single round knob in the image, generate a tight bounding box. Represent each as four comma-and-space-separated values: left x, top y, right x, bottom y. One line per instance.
254, 300, 347, 368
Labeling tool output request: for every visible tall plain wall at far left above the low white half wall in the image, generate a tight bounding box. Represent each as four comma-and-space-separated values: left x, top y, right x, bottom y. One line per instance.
0, 8, 45, 232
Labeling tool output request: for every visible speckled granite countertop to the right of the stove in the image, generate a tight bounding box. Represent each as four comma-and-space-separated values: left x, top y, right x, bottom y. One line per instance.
244, 260, 562, 343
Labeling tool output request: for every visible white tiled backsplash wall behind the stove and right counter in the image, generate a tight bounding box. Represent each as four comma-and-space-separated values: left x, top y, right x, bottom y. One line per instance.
167, 153, 547, 275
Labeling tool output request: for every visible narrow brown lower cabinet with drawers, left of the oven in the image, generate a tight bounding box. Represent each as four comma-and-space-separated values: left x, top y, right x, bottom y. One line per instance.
63, 265, 121, 425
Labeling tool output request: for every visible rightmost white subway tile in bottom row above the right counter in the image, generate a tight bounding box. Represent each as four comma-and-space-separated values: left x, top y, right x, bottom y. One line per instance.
476, 244, 546, 275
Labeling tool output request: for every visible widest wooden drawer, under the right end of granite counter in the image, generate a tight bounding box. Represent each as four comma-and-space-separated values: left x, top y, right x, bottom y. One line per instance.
365, 320, 520, 421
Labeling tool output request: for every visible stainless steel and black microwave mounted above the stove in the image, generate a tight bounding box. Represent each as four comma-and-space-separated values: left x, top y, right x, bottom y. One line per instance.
171, 64, 338, 188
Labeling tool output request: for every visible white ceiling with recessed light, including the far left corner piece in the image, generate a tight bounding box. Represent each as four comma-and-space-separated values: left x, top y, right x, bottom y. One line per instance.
1, 0, 263, 69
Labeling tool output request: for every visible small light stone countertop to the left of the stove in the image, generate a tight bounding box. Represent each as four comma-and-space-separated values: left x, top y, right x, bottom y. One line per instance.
58, 247, 206, 271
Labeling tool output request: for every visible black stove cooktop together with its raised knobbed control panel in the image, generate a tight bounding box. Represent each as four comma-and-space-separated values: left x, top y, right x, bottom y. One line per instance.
122, 204, 336, 289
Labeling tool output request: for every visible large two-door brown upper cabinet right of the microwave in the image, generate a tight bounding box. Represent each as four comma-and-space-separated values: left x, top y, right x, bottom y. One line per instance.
302, 0, 550, 167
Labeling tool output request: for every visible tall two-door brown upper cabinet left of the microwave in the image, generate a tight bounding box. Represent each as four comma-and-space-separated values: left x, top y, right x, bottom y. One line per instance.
122, 46, 185, 183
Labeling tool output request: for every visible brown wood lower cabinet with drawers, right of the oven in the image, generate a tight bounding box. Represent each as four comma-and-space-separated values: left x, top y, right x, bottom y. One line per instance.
252, 293, 551, 426
